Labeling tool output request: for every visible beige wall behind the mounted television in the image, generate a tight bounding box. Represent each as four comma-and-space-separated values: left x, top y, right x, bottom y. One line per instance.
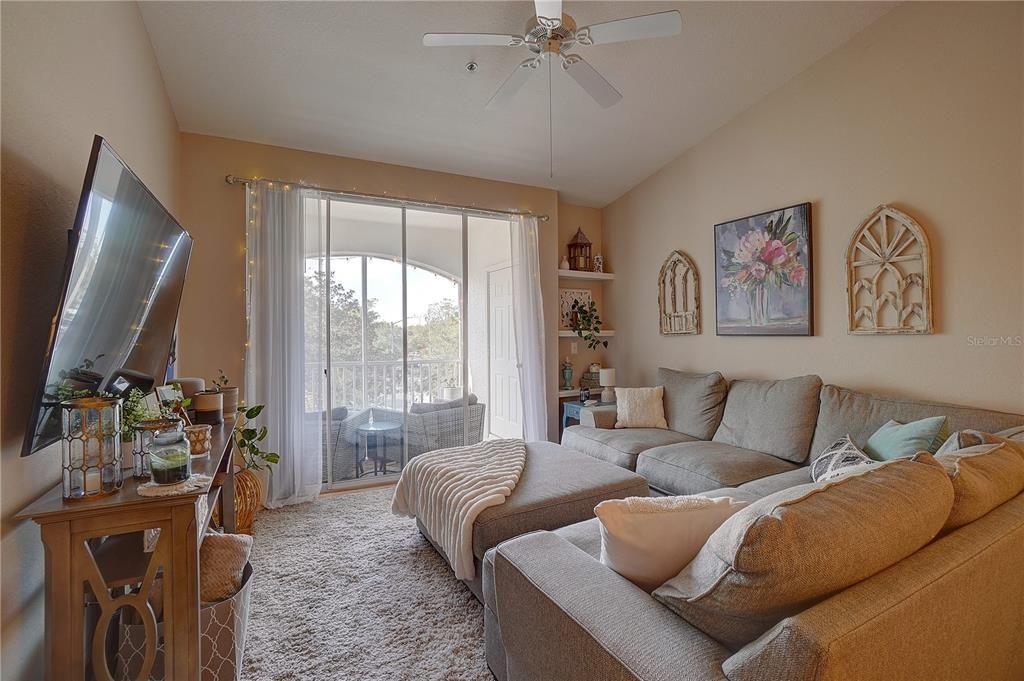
0, 2, 177, 681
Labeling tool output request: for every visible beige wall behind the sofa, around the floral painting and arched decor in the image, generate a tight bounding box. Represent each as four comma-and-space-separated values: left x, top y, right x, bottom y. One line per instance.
604, 3, 1024, 412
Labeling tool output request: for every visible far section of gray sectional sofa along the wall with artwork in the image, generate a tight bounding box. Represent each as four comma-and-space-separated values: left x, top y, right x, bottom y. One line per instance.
562, 369, 1024, 497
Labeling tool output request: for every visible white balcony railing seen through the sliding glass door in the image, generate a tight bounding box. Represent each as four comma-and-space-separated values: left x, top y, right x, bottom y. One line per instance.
305, 359, 462, 413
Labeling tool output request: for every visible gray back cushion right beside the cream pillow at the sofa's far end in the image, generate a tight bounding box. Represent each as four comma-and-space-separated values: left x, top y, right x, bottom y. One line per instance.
657, 368, 729, 439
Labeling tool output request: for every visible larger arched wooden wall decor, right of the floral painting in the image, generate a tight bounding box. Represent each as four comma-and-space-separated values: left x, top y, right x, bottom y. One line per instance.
846, 206, 932, 334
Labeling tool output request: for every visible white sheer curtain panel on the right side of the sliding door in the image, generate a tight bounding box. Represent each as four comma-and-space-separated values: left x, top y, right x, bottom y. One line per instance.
512, 215, 548, 441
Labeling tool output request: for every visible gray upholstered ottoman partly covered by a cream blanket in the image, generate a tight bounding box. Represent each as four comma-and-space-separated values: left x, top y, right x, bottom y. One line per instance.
417, 442, 647, 602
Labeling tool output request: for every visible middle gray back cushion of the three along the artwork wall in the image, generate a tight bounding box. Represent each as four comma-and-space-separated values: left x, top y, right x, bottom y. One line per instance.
713, 376, 835, 464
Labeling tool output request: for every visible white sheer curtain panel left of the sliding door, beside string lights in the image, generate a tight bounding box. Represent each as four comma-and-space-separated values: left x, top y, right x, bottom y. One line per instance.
245, 182, 322, 507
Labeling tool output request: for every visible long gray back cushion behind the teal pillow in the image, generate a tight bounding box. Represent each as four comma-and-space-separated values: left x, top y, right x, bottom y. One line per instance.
811, 385, 1024, 460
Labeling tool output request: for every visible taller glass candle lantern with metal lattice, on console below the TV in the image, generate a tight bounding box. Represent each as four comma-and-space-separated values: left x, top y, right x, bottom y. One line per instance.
60, 397, 123, 499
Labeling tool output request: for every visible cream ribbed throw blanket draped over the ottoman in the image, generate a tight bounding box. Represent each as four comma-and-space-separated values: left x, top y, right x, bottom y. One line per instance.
391, 439, 526, 580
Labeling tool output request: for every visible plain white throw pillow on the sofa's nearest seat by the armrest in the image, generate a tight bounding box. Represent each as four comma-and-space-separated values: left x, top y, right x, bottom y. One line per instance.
594, 496, 746, 593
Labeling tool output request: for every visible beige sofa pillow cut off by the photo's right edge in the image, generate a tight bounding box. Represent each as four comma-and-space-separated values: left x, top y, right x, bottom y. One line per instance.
935, 435, 1024, 530
